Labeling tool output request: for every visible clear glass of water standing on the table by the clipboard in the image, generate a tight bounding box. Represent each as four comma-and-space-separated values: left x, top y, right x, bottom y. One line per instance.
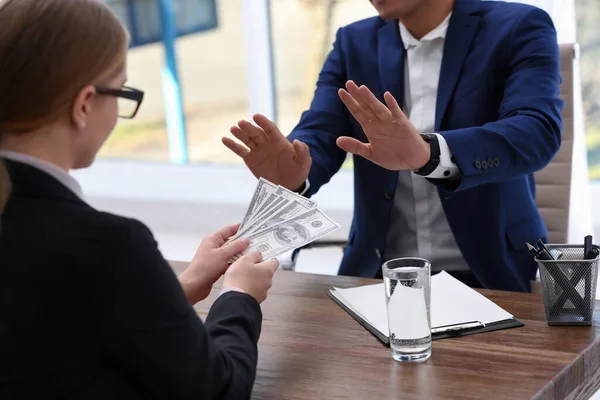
382, 258, 431, 362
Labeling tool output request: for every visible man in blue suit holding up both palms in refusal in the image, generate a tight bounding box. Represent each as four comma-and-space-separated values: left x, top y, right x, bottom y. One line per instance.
223, 0, 563, 291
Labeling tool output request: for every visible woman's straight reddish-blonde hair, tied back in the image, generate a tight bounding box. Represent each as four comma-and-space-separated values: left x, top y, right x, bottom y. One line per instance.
0, 0, 129, 214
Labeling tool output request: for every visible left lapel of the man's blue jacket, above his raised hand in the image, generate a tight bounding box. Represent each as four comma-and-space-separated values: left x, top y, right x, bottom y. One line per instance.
377, 21, 405, 110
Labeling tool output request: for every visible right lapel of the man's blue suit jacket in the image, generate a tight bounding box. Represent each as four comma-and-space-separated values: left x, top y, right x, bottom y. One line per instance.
435, 0, 481, 132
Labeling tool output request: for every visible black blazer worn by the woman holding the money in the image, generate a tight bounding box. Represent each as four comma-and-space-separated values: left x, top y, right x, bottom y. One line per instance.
0, 162, 262, 399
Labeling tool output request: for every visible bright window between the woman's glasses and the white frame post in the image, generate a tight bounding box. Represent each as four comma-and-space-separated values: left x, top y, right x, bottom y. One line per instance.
100, 0, 248, 163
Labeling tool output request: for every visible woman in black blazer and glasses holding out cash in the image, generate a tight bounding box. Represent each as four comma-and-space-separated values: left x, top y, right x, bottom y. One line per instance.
0, 0, 277, 399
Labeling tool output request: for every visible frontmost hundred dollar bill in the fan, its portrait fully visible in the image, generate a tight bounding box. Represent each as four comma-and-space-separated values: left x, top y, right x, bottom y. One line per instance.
234, 209, 340, 260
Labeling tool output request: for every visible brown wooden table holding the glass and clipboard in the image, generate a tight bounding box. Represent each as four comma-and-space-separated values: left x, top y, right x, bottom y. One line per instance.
173, 263, 600, 400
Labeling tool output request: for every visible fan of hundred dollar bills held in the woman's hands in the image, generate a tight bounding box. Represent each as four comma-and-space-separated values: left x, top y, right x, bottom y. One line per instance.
230, 178, 340, 261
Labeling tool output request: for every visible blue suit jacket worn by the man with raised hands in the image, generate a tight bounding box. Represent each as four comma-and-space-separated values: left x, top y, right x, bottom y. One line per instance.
289, 0, 563, 291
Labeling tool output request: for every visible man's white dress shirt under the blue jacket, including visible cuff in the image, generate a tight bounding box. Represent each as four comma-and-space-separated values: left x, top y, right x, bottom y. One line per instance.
384, 15, 468, 271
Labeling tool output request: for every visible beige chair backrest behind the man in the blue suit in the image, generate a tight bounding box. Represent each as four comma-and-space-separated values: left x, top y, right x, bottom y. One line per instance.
535, 43, 577, 243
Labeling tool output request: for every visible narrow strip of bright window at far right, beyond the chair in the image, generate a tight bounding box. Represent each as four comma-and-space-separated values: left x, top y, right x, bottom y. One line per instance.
575, 0, 600, 180
